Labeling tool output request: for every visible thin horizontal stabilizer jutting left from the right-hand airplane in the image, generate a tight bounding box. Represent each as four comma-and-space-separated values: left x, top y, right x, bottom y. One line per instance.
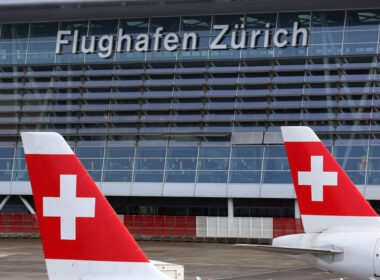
234, 244, 343, 255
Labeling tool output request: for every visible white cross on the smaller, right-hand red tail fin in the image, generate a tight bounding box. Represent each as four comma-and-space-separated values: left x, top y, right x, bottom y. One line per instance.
298, 156, 338, 201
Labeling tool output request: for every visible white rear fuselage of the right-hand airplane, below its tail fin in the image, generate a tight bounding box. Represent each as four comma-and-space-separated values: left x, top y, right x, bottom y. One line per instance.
273, 232, 380, 280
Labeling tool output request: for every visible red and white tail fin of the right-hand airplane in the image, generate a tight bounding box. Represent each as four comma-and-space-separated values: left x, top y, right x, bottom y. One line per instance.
281, 127, 380, 232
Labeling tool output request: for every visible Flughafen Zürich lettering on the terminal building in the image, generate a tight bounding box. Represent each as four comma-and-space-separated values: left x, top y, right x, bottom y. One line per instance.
55, 22, 309, 58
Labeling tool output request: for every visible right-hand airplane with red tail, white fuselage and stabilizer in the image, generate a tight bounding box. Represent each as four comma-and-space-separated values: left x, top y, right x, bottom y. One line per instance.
241, 127, 380, 280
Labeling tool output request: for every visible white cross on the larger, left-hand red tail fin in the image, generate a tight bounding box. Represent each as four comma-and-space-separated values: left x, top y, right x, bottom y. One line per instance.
43, 175, 95, 240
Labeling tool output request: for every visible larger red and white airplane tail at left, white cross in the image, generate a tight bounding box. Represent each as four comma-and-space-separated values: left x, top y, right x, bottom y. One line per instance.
21, 132, 170, 280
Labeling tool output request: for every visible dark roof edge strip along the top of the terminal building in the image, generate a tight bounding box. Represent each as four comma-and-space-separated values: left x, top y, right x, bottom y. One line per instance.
0, 0, 380, 22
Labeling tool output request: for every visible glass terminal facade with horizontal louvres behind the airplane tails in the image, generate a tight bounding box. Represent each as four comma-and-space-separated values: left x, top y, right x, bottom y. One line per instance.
0, 10, 380, 199
